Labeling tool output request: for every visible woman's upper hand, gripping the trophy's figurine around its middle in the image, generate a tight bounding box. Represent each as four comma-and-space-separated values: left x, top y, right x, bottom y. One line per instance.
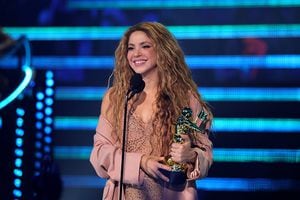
170, 134, 197, 163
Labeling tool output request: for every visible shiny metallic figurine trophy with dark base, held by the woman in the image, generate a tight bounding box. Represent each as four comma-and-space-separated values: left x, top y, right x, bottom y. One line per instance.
164, 107, 208, 188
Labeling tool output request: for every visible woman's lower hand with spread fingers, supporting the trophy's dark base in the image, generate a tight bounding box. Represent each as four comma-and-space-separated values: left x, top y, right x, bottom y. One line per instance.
141, 155, 171, 182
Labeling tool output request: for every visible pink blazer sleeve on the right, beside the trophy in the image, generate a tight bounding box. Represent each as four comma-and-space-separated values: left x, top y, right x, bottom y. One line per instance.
187, 96, 213, 180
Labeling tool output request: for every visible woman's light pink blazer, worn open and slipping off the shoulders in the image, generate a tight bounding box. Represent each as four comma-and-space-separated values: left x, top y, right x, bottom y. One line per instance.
90, 94, 212, 200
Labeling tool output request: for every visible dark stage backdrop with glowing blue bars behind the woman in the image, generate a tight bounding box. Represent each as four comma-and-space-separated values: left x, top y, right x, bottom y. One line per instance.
0, 0, 300, 200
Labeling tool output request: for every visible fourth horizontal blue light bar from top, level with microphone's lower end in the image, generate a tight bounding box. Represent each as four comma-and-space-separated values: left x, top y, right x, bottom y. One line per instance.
55, 87, 300, 102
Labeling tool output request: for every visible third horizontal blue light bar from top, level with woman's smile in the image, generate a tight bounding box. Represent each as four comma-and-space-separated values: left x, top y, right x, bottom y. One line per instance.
0, 55, 300, 69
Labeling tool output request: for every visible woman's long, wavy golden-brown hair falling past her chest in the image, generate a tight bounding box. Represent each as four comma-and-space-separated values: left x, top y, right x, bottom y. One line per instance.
109, 22, 209, 155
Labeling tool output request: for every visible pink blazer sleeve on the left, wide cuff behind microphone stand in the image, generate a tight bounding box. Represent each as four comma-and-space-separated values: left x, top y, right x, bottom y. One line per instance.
90, 115, 144, 185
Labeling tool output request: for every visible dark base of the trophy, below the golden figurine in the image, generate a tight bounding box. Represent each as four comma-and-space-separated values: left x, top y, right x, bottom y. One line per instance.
159, 169, 186, 190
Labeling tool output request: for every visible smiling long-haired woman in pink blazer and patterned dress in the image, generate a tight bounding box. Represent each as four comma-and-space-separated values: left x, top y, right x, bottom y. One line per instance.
90, 22, 212, 200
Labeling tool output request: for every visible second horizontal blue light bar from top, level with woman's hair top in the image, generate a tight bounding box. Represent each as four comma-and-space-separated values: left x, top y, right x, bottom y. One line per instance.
4, 24, 300, 40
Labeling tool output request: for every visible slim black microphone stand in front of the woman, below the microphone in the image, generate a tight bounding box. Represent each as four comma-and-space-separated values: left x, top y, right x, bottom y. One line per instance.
119, 91, 135, 200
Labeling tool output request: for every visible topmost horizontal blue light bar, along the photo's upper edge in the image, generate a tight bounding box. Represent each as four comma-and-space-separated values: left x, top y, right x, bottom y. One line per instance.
67, 0, 300, 11
